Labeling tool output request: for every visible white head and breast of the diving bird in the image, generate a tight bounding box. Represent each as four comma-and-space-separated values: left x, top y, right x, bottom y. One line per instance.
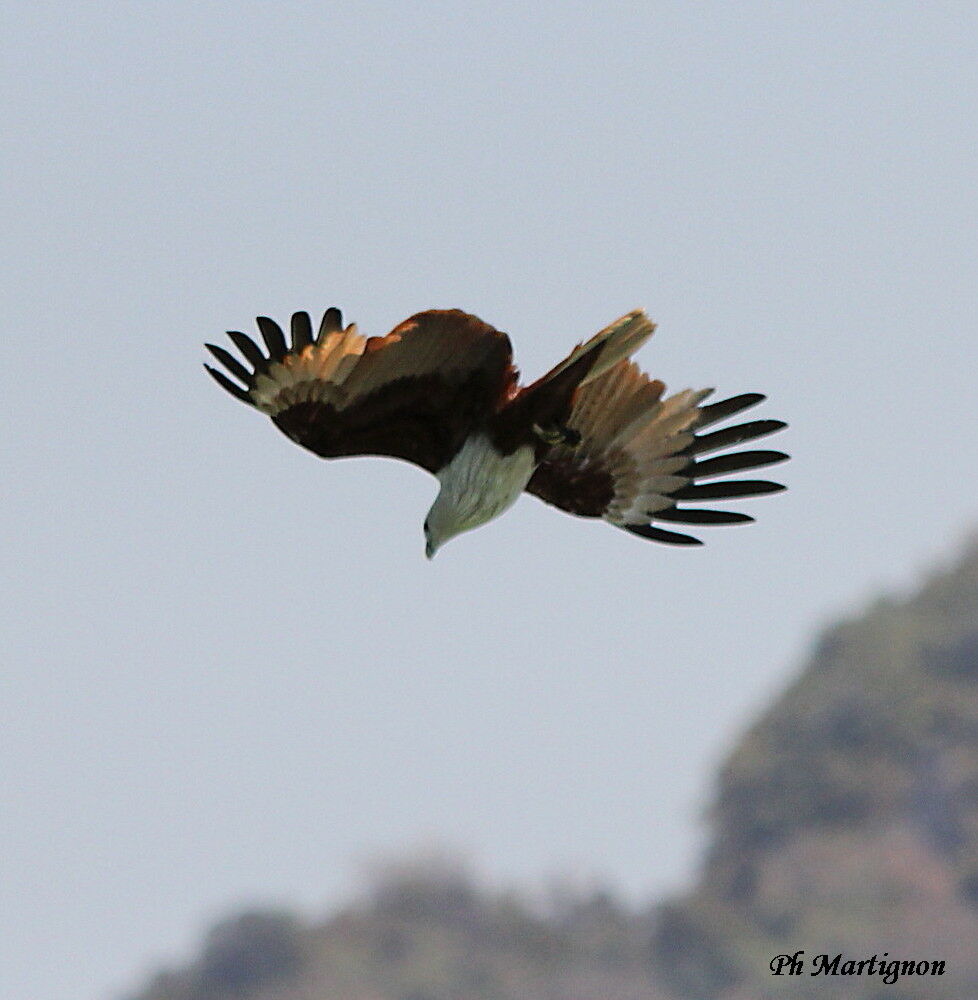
424, 436, 534, 559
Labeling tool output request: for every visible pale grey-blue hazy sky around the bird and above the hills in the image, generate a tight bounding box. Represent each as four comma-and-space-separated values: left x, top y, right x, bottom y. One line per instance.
7, 0, 978, 1000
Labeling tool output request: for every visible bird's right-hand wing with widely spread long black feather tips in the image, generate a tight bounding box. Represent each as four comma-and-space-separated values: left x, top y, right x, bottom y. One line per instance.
526, 361, 788, 545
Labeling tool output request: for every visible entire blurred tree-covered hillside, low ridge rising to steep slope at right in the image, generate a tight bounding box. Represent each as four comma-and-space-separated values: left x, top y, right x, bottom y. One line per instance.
131, 546, 978, 1000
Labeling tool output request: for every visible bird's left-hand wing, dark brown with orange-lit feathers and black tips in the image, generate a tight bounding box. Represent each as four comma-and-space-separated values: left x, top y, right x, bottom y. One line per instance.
204, 308, 516, 472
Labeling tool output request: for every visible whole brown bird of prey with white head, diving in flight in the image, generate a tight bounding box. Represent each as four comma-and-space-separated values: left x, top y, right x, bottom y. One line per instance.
204, 308, 788, 558
